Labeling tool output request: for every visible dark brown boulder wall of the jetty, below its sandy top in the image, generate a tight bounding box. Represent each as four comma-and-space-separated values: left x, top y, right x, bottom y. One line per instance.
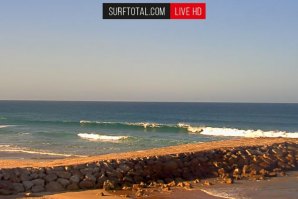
0, 141, 298, 195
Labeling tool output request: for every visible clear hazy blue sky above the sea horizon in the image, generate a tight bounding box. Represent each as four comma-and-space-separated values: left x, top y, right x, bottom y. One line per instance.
0, 0, 298, 103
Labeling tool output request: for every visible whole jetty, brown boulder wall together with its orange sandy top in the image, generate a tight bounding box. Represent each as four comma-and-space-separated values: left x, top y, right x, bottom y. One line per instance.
0, 138, 298, 199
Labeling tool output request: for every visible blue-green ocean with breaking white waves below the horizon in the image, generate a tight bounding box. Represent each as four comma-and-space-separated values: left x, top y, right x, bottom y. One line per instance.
0, 101, 298, 155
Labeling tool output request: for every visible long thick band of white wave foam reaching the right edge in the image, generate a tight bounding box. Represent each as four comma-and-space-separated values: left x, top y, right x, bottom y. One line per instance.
198, 127, 298, 138
